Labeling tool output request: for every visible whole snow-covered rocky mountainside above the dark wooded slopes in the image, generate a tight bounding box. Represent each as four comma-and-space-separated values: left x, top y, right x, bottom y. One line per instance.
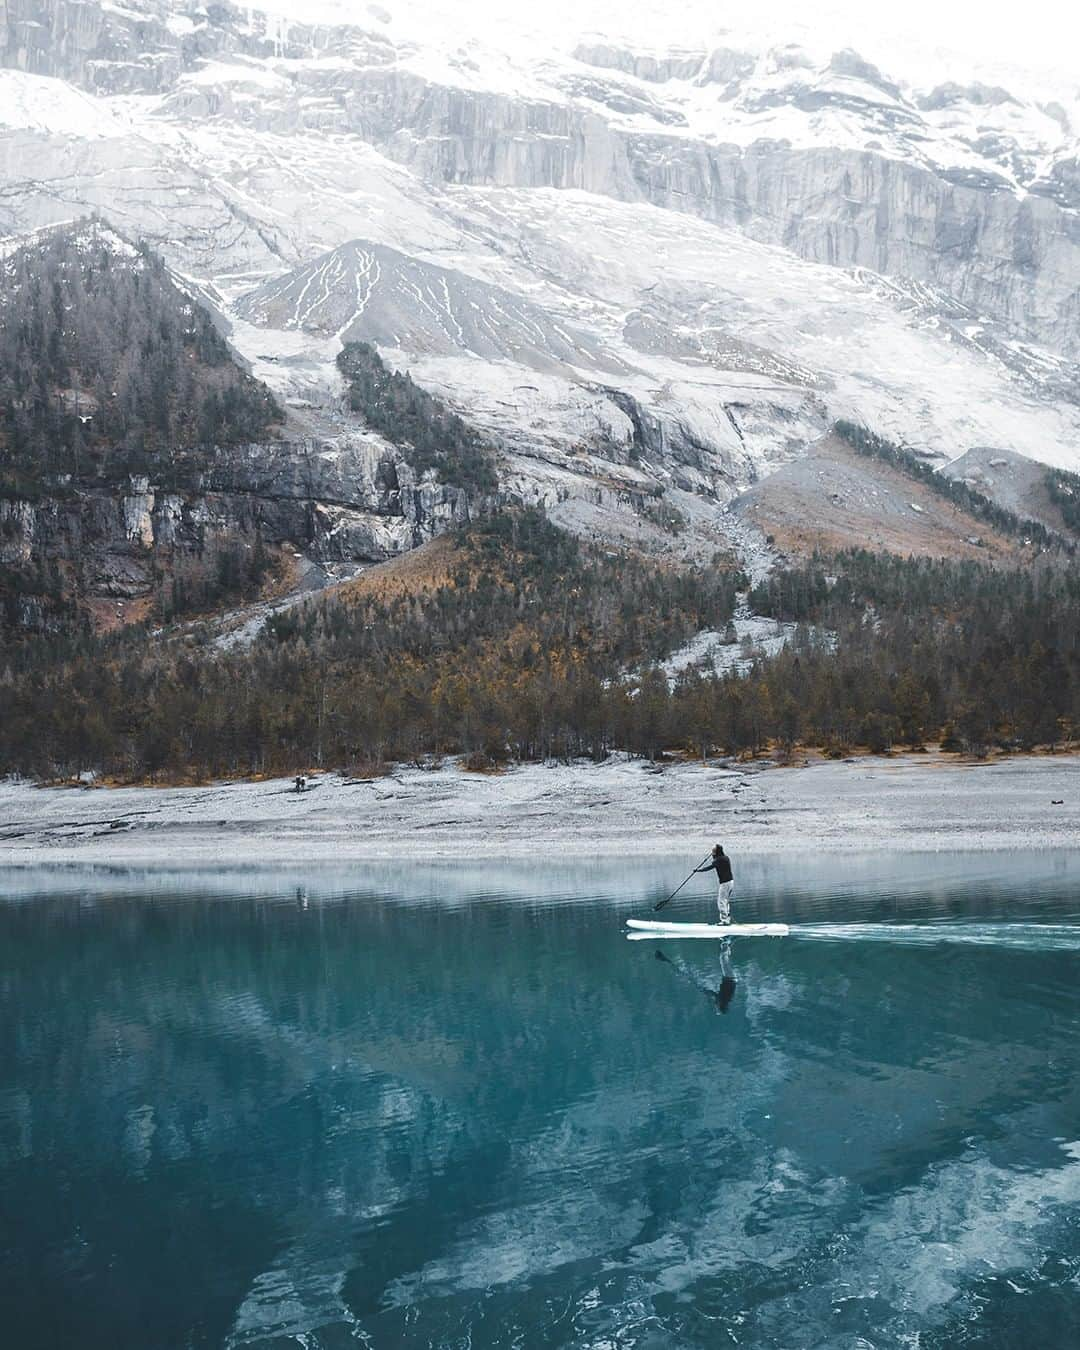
0, 0, 1080, 553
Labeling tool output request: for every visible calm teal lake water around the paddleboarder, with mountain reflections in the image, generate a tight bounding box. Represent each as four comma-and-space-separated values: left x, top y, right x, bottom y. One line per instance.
0, 853, 1080, 1350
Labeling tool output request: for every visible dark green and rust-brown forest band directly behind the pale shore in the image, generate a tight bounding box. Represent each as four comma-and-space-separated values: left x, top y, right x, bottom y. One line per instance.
0, 510, 1080, 782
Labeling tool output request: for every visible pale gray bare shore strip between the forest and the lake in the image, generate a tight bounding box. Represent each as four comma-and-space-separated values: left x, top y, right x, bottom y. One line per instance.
0, 756, 1080, 868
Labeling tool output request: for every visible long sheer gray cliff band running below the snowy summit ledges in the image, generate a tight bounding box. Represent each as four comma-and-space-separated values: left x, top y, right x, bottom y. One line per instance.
325, 78, 1080, 358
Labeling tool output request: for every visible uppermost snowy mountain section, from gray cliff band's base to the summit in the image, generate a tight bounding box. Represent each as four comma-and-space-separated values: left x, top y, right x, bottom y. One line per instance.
0, 0, 1080, 356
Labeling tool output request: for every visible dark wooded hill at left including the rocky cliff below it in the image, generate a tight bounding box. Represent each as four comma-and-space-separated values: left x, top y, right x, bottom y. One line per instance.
0, 221, 468, 632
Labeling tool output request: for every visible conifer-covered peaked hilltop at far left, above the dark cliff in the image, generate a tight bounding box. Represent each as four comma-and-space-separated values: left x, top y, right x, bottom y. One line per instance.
0, 221, 282, 501
